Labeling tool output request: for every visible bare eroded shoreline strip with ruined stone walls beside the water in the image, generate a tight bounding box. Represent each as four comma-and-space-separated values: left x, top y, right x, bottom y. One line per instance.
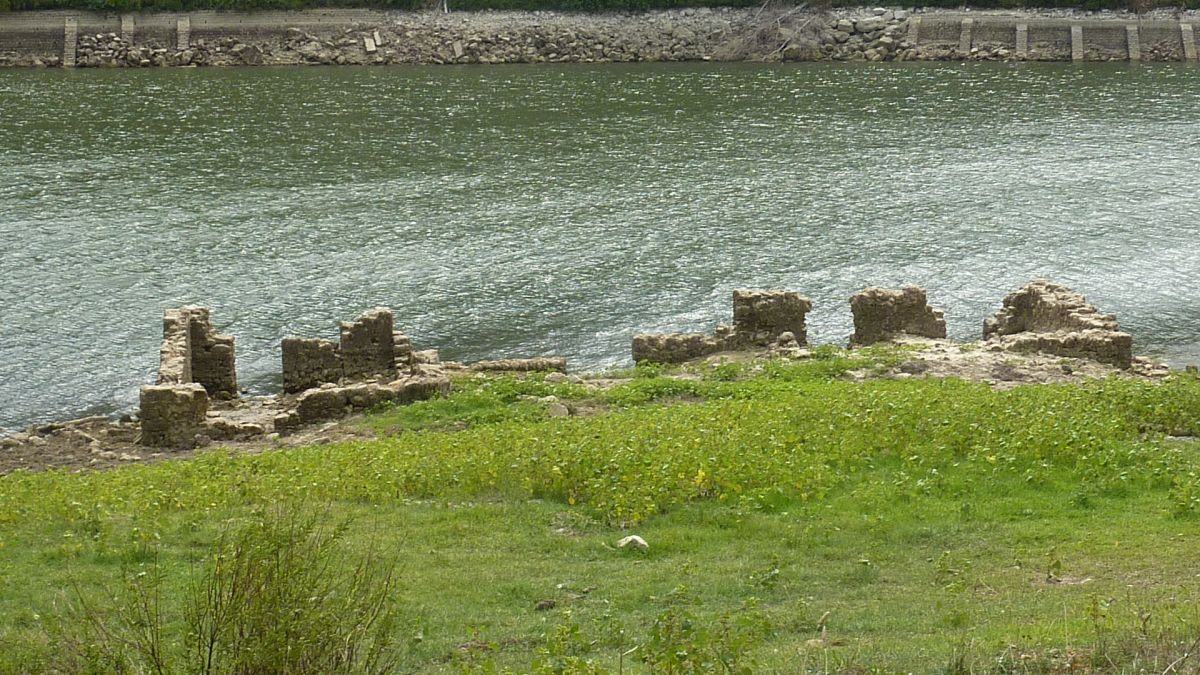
0, 280, 1171, 474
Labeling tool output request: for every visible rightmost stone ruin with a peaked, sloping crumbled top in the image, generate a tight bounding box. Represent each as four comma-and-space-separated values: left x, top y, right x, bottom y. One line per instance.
983, 279, 1133, 368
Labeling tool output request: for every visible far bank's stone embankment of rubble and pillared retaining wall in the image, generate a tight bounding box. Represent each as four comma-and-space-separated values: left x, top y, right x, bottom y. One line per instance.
0, 7, 1200, 67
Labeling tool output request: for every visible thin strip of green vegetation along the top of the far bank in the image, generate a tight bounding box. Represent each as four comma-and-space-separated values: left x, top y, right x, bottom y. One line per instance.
7, 0, 1200, 17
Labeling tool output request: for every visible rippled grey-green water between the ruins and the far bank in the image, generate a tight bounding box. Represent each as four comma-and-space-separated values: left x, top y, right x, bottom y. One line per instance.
0, 64, 1200, 426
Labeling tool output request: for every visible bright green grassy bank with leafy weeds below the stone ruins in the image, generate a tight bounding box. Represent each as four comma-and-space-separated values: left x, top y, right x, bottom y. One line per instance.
0, 350, 1200, 673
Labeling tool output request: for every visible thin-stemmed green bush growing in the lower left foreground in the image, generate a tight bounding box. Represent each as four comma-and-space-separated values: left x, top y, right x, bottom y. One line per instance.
52, 509, 397, 675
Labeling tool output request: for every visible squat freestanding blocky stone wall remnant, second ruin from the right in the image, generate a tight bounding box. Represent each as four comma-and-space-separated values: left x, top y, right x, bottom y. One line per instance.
850, 286, 946, 345
